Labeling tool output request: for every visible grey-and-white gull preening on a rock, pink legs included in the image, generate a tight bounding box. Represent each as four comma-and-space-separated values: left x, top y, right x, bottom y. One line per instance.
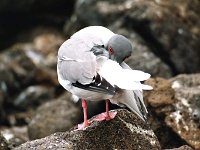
57, 26, 152, 130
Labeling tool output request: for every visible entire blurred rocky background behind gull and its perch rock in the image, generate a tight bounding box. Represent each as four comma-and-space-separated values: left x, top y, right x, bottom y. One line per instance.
0, 0, 200, 149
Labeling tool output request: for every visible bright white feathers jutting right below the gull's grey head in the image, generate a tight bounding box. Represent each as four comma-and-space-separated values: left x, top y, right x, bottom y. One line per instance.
98, 60, 152, 91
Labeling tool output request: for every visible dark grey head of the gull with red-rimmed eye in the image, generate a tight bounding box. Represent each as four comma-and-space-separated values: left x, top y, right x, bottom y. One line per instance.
107, 34, 132, 64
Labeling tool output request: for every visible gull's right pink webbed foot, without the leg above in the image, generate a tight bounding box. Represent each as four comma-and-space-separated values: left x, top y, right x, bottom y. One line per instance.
93, 111, 117, 121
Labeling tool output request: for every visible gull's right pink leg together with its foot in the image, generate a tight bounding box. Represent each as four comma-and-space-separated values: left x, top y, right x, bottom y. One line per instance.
94, 99, 117, 121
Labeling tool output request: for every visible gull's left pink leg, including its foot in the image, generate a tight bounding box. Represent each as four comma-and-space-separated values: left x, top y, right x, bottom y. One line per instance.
78, 98, 90, 130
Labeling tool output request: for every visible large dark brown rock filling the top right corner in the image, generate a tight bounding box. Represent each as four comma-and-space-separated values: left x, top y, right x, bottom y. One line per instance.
65, 0, 200, 74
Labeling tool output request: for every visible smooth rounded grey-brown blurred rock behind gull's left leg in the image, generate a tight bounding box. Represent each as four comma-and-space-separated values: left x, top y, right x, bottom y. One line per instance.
28, 95, 81, 139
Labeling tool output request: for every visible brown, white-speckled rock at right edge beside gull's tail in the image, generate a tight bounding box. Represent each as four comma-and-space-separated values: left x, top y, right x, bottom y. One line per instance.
145, 74, 200, 149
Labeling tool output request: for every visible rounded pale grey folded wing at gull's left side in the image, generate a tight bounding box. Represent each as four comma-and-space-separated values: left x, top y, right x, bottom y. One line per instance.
57, 39, 96, 84
